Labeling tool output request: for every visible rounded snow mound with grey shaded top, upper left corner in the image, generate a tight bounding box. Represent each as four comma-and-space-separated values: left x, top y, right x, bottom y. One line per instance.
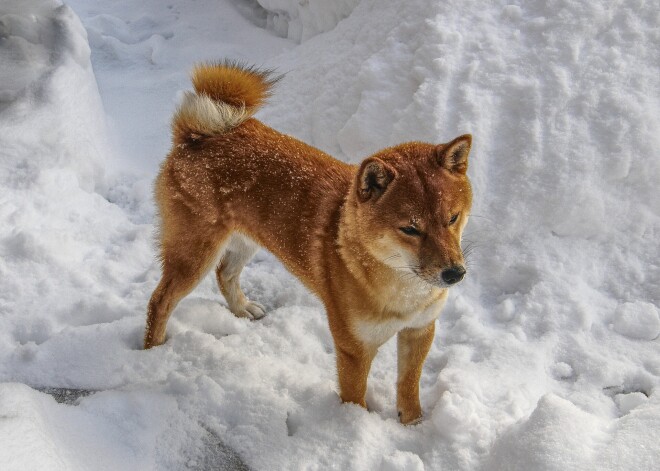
0, 0, 107, 191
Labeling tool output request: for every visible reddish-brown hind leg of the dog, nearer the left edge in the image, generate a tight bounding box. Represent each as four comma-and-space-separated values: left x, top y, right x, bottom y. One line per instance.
144, 221, 230, 349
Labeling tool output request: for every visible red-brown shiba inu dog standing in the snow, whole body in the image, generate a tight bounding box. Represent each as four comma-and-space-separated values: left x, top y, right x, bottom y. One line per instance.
144, 62, 472, 424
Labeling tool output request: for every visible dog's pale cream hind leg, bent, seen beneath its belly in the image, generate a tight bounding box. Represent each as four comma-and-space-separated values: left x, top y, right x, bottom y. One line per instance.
215, 232, 266, 319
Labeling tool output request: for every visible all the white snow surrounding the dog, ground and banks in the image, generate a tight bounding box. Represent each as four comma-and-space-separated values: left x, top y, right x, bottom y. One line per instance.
0, 0, 660, 470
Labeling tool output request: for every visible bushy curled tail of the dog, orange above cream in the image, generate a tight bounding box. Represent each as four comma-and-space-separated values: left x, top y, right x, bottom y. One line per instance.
172, 61, 280, 145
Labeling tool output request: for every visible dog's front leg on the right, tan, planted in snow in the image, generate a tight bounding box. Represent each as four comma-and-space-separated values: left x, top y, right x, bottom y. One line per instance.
396, 321, 435, 425
